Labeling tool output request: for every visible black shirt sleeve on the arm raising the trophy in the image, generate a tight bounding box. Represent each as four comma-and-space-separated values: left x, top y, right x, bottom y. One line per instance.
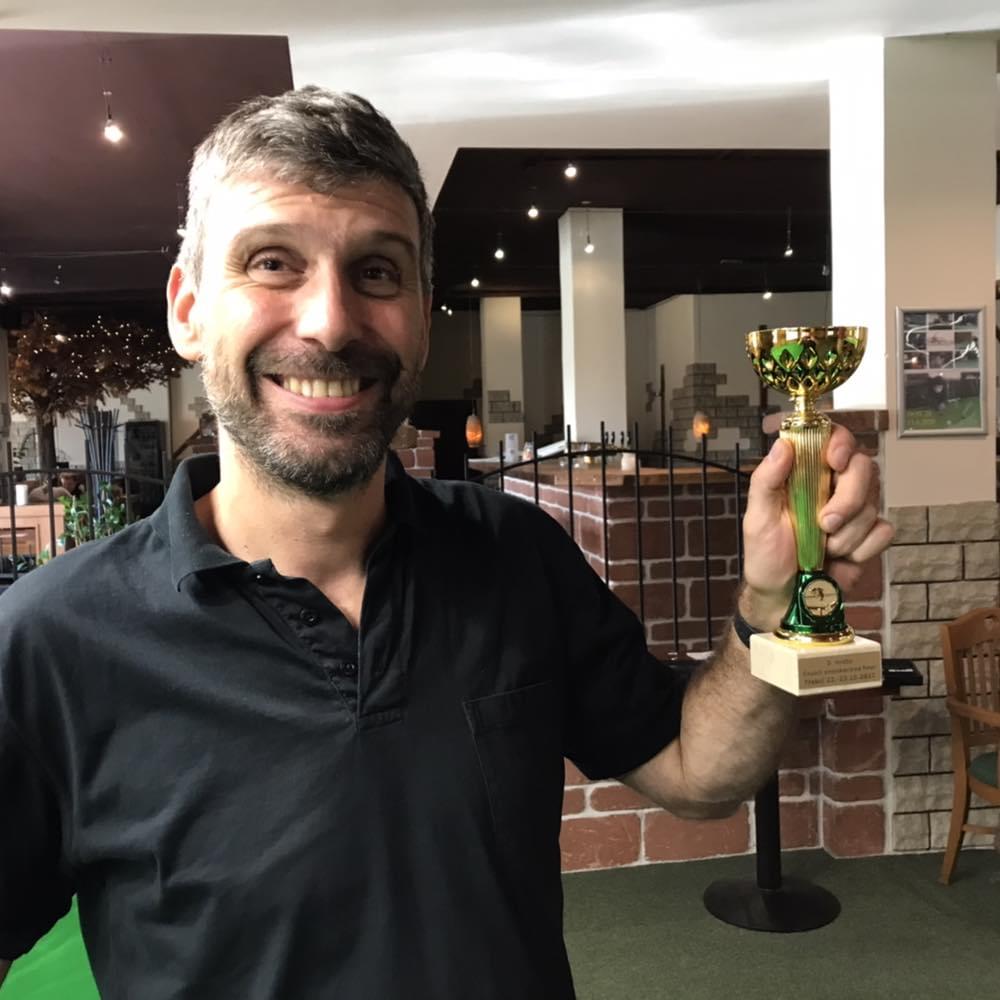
542, 514, 686, 781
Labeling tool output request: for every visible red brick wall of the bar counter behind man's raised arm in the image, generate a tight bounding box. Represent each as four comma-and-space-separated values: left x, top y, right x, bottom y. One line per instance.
505, 412, 888, 870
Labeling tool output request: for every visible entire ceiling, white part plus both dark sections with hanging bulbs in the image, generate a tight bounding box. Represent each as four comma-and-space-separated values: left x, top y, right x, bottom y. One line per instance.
0, 0, 1000, 307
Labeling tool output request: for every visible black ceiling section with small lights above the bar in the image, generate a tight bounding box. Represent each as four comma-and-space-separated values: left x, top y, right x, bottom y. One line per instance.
434, 149, 830, 309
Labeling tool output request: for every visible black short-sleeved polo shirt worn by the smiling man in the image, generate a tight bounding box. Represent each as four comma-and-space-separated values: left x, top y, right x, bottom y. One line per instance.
0, 457, 681, 1000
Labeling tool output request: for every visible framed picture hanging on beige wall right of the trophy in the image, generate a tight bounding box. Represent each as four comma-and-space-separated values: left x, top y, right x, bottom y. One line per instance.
896, 309, 986, 437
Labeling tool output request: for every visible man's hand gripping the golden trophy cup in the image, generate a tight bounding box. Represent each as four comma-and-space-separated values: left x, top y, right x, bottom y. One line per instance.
740, 425, 893, 629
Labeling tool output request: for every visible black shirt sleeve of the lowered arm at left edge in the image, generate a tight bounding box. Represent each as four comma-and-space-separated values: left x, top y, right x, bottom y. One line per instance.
0, 712, 73, 961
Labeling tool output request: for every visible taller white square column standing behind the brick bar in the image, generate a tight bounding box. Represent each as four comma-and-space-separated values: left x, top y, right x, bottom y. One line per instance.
559, 208, 628, 441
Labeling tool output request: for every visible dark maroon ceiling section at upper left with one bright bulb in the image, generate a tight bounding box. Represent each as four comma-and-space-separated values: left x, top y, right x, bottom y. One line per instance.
0, 31, 291, 303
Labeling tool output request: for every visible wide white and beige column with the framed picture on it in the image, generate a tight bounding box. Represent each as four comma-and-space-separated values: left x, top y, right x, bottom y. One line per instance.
830, 37, 997, 506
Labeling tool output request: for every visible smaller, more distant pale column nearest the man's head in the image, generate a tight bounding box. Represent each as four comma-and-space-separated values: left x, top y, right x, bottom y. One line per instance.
479, 296, 524, 457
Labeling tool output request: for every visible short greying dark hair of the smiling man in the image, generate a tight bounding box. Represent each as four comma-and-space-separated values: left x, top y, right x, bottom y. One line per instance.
177, 86, 434, 294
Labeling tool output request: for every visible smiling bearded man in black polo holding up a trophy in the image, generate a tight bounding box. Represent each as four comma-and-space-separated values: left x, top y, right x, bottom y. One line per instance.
0, 88, 891, 1000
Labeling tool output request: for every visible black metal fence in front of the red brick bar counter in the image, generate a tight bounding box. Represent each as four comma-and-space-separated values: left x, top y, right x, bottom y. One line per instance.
465, 417, 759, 658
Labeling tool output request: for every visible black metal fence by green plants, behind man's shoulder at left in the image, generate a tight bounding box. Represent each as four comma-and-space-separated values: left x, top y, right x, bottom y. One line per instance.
0, 443, 170, 589
